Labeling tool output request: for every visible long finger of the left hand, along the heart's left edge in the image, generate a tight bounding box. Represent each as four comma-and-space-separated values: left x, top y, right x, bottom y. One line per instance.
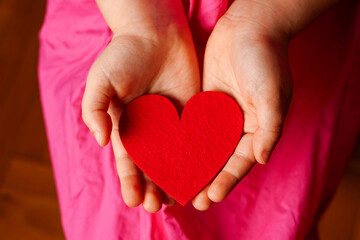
109, 102, 143, 207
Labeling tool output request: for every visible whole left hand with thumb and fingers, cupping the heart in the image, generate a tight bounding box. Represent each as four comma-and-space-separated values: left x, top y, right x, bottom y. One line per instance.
83, 0, 200, 212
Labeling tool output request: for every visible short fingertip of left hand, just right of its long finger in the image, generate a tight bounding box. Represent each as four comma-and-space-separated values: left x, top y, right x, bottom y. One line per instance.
143, 174, 162, 213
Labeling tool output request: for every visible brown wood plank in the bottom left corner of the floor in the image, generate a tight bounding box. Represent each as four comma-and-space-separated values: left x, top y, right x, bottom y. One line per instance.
0, 188, 64, 239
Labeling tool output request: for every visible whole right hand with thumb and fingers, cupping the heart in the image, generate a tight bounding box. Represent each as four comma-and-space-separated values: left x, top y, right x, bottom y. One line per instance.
193, 1, 292, 210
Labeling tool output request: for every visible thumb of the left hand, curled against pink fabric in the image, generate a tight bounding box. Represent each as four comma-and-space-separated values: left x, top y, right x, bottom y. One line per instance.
82, 62, 114, 146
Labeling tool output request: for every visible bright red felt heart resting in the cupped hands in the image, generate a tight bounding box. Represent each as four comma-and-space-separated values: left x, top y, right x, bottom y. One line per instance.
120, 92, 243, 206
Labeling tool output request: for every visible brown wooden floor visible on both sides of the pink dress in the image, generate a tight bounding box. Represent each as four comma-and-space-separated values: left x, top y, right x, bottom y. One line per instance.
0, 0, 360, 240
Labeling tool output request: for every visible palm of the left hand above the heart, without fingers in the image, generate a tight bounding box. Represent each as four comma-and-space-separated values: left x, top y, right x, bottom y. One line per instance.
100, 36, 199, 103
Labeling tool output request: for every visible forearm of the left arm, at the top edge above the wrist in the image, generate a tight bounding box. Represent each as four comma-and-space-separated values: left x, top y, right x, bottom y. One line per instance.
96, 0, 187, 34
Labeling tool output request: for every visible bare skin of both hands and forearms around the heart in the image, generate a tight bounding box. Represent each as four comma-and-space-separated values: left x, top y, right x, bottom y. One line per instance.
82, 0, 337, 212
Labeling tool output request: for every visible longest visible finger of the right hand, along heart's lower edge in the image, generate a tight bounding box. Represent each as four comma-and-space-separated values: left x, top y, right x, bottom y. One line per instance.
208, 133, 256, 202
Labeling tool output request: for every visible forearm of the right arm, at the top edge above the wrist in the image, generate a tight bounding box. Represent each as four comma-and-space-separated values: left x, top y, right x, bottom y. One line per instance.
224, 0, 339, 38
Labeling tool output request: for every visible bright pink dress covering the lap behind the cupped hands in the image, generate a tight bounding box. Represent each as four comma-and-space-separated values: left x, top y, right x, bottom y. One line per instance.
39, 0, 360, 240
